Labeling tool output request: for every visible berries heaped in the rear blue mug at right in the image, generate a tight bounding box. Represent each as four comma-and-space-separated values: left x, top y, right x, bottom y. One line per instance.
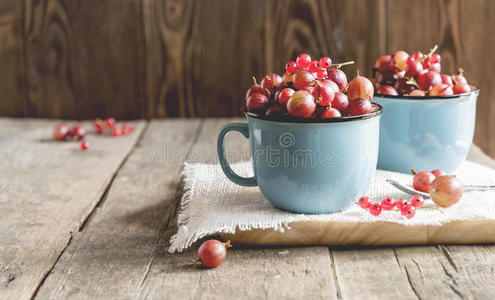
373, 46, 471, 97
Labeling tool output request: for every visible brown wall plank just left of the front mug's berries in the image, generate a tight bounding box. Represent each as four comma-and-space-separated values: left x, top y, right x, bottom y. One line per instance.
143, 0, 262, 117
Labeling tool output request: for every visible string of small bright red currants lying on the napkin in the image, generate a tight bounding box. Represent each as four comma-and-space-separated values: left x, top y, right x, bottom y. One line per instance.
358, 195, 425, 219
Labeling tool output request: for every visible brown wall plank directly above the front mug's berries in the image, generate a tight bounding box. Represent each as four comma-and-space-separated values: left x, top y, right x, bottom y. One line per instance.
262, 0, 385, 78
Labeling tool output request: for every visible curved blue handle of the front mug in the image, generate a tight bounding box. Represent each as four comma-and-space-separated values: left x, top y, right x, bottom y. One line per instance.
217, 123, 258, 186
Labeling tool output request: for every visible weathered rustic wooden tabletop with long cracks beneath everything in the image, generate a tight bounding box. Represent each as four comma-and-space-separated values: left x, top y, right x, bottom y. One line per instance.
0, 119, 495, 299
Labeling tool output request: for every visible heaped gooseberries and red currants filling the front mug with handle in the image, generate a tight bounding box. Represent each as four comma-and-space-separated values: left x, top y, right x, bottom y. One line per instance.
246, 53, 376, 119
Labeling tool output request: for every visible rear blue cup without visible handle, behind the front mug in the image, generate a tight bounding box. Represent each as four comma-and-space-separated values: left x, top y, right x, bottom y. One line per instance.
373, 87, 479, 173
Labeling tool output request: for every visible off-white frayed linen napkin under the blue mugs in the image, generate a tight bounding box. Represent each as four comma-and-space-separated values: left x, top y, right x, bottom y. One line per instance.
169, 161, 495, 253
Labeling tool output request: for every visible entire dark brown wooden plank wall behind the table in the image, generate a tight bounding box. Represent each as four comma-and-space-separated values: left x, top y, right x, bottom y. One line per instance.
0, 0, 495, 156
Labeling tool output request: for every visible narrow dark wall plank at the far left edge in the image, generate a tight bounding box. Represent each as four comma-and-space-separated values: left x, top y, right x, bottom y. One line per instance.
0, 0, 26, 117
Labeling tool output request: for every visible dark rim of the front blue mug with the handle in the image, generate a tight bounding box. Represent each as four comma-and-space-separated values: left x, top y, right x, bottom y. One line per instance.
244, 102, 383, 124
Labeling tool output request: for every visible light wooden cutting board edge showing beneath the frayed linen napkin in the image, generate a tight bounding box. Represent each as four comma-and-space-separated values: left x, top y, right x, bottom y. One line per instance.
222, 219, 495, 246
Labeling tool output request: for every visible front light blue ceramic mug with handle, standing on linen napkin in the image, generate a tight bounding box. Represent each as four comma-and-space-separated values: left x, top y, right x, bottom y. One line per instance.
217, 105, 382, 214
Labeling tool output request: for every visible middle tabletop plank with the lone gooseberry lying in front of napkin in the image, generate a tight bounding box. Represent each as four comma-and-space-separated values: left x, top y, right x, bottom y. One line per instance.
38, 119, 337, 299
